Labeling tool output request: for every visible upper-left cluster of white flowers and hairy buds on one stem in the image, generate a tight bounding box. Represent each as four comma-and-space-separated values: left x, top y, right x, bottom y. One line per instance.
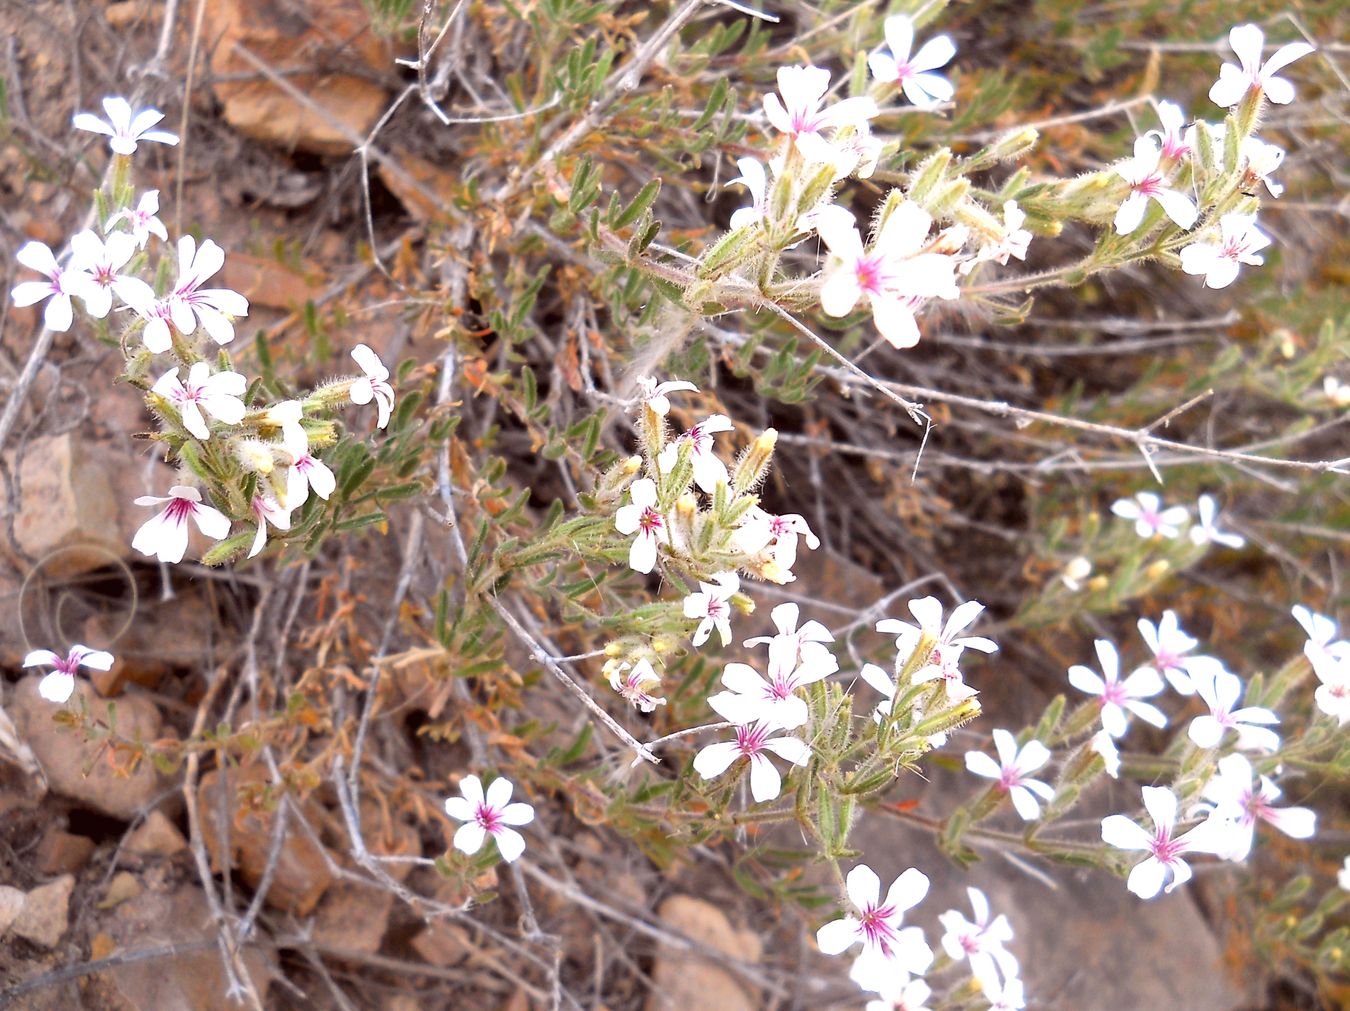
11, 97, 394, 563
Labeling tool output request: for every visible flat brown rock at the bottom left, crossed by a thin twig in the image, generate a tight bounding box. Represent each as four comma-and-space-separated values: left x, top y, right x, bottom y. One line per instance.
99, 885, 275, 1011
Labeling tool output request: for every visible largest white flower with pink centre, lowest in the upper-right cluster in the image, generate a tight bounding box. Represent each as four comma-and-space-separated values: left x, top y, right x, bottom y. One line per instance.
815, 201, 961, 347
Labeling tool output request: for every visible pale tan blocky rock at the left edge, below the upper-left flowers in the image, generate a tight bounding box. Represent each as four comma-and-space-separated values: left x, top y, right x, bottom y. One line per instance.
0, 432, 132, 579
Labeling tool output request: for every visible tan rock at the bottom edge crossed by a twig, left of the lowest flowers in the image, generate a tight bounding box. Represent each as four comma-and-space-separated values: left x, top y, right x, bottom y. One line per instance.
647, 895, 760, 1011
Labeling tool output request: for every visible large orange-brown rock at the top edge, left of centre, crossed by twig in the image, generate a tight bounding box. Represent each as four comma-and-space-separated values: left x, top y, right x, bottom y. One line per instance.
199, 0, 393, 154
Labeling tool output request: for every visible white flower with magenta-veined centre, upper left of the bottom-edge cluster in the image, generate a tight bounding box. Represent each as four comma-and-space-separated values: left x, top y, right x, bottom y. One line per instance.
815, 864, 933, 976
